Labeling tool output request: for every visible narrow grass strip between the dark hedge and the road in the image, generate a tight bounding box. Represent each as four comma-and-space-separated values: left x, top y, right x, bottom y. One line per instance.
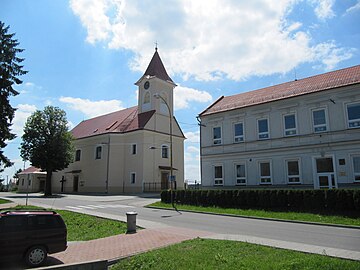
149, 202, 360, 226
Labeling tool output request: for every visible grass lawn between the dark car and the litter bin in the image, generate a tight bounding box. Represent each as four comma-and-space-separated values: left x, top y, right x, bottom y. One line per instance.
4, 205, 127, 241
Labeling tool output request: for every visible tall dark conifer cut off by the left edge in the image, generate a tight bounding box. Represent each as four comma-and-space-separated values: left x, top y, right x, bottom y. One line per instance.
0, 21, 27, 171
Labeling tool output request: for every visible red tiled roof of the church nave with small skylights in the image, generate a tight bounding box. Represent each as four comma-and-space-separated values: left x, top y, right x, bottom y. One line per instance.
71, 106, 155, 139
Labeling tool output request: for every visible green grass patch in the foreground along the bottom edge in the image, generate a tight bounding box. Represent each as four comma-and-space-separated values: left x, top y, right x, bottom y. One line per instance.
111, 239, 360, 270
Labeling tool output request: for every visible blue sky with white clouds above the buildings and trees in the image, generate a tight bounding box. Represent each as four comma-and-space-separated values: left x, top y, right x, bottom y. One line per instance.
0, 0, 360, 183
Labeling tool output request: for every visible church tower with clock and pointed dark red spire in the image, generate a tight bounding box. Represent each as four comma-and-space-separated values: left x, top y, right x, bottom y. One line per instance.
135, 48, 176, 115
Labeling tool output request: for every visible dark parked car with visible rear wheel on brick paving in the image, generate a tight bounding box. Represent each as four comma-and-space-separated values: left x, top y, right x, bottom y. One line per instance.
0, 211, 67, 267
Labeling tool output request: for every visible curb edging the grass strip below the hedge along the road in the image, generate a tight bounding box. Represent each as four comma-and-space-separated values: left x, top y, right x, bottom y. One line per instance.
145, 206, 360, 230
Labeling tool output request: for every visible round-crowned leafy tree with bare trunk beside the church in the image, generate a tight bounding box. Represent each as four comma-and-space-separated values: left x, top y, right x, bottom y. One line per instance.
20, 106, 74, 196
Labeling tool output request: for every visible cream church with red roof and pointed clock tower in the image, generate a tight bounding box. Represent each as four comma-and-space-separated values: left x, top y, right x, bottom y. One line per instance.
52, 48, 185, 194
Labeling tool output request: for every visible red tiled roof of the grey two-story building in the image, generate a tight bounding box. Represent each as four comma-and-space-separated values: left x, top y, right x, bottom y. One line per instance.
200, 65, 360, 116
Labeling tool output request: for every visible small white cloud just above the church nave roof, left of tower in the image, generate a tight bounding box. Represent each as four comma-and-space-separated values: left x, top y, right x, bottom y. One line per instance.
59, 97, 124, 118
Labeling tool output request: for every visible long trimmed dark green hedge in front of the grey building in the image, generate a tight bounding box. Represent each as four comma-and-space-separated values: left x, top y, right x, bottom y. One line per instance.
161, 189, 360, 211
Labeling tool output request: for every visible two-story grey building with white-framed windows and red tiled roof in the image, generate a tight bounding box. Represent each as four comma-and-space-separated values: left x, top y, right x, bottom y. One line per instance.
199, 65, 360, 189
